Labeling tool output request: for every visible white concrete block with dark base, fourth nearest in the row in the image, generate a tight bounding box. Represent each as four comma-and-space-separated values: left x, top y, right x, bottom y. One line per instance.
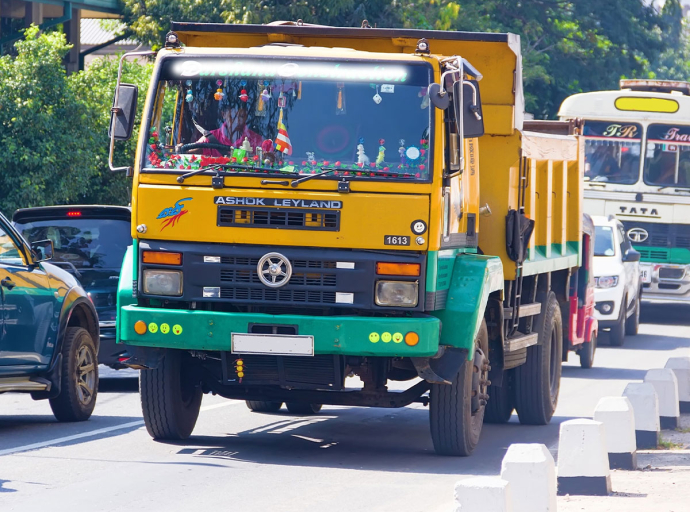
594, 396, 637, 469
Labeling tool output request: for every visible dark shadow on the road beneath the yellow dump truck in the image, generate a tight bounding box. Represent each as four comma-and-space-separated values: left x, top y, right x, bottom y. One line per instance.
160, 408, 570, 475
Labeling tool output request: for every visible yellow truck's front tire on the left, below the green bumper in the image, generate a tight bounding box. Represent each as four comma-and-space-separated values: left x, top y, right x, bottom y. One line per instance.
139, 350, 202, 440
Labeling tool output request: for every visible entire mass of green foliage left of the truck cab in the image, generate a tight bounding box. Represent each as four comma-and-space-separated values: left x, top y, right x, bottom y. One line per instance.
0, 27, 152, 215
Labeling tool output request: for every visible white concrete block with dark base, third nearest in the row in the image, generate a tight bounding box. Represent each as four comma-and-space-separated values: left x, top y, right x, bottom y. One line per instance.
557, 418, 611, 496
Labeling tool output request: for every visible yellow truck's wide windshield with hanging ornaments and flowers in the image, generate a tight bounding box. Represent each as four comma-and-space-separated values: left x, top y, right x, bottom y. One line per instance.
143, 57, 433, 181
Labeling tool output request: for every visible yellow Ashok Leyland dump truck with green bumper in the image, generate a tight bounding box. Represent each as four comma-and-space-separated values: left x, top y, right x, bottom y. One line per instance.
111, 22, 582, 455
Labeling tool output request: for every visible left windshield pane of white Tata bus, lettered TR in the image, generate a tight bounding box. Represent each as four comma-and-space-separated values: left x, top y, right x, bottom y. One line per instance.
583, 121, 642, 184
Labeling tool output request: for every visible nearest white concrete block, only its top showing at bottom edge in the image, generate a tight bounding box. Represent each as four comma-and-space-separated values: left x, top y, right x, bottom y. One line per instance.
455, 476, 513, 512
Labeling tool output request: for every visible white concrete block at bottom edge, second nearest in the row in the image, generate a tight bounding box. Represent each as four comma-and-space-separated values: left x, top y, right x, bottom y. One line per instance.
501, 444, 556, 512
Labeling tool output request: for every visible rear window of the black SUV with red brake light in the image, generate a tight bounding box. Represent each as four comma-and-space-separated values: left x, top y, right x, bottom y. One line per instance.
15, 218, 132, 269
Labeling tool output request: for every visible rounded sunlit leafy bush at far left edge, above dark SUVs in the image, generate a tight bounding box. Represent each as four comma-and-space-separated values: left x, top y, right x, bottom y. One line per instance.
0, 27, 96, 215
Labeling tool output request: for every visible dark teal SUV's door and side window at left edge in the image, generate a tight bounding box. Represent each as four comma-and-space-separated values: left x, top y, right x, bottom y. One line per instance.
0, 221, 54, 366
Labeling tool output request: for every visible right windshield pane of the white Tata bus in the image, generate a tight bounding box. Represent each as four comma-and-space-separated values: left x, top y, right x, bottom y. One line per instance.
644, 124, 690, 188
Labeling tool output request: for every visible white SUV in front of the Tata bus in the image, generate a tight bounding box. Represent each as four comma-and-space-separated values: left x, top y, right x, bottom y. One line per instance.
592, 216, 641, 347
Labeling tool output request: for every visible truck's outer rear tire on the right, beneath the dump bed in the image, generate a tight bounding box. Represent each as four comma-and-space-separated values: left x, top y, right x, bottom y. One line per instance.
515, 292, 563, 425
